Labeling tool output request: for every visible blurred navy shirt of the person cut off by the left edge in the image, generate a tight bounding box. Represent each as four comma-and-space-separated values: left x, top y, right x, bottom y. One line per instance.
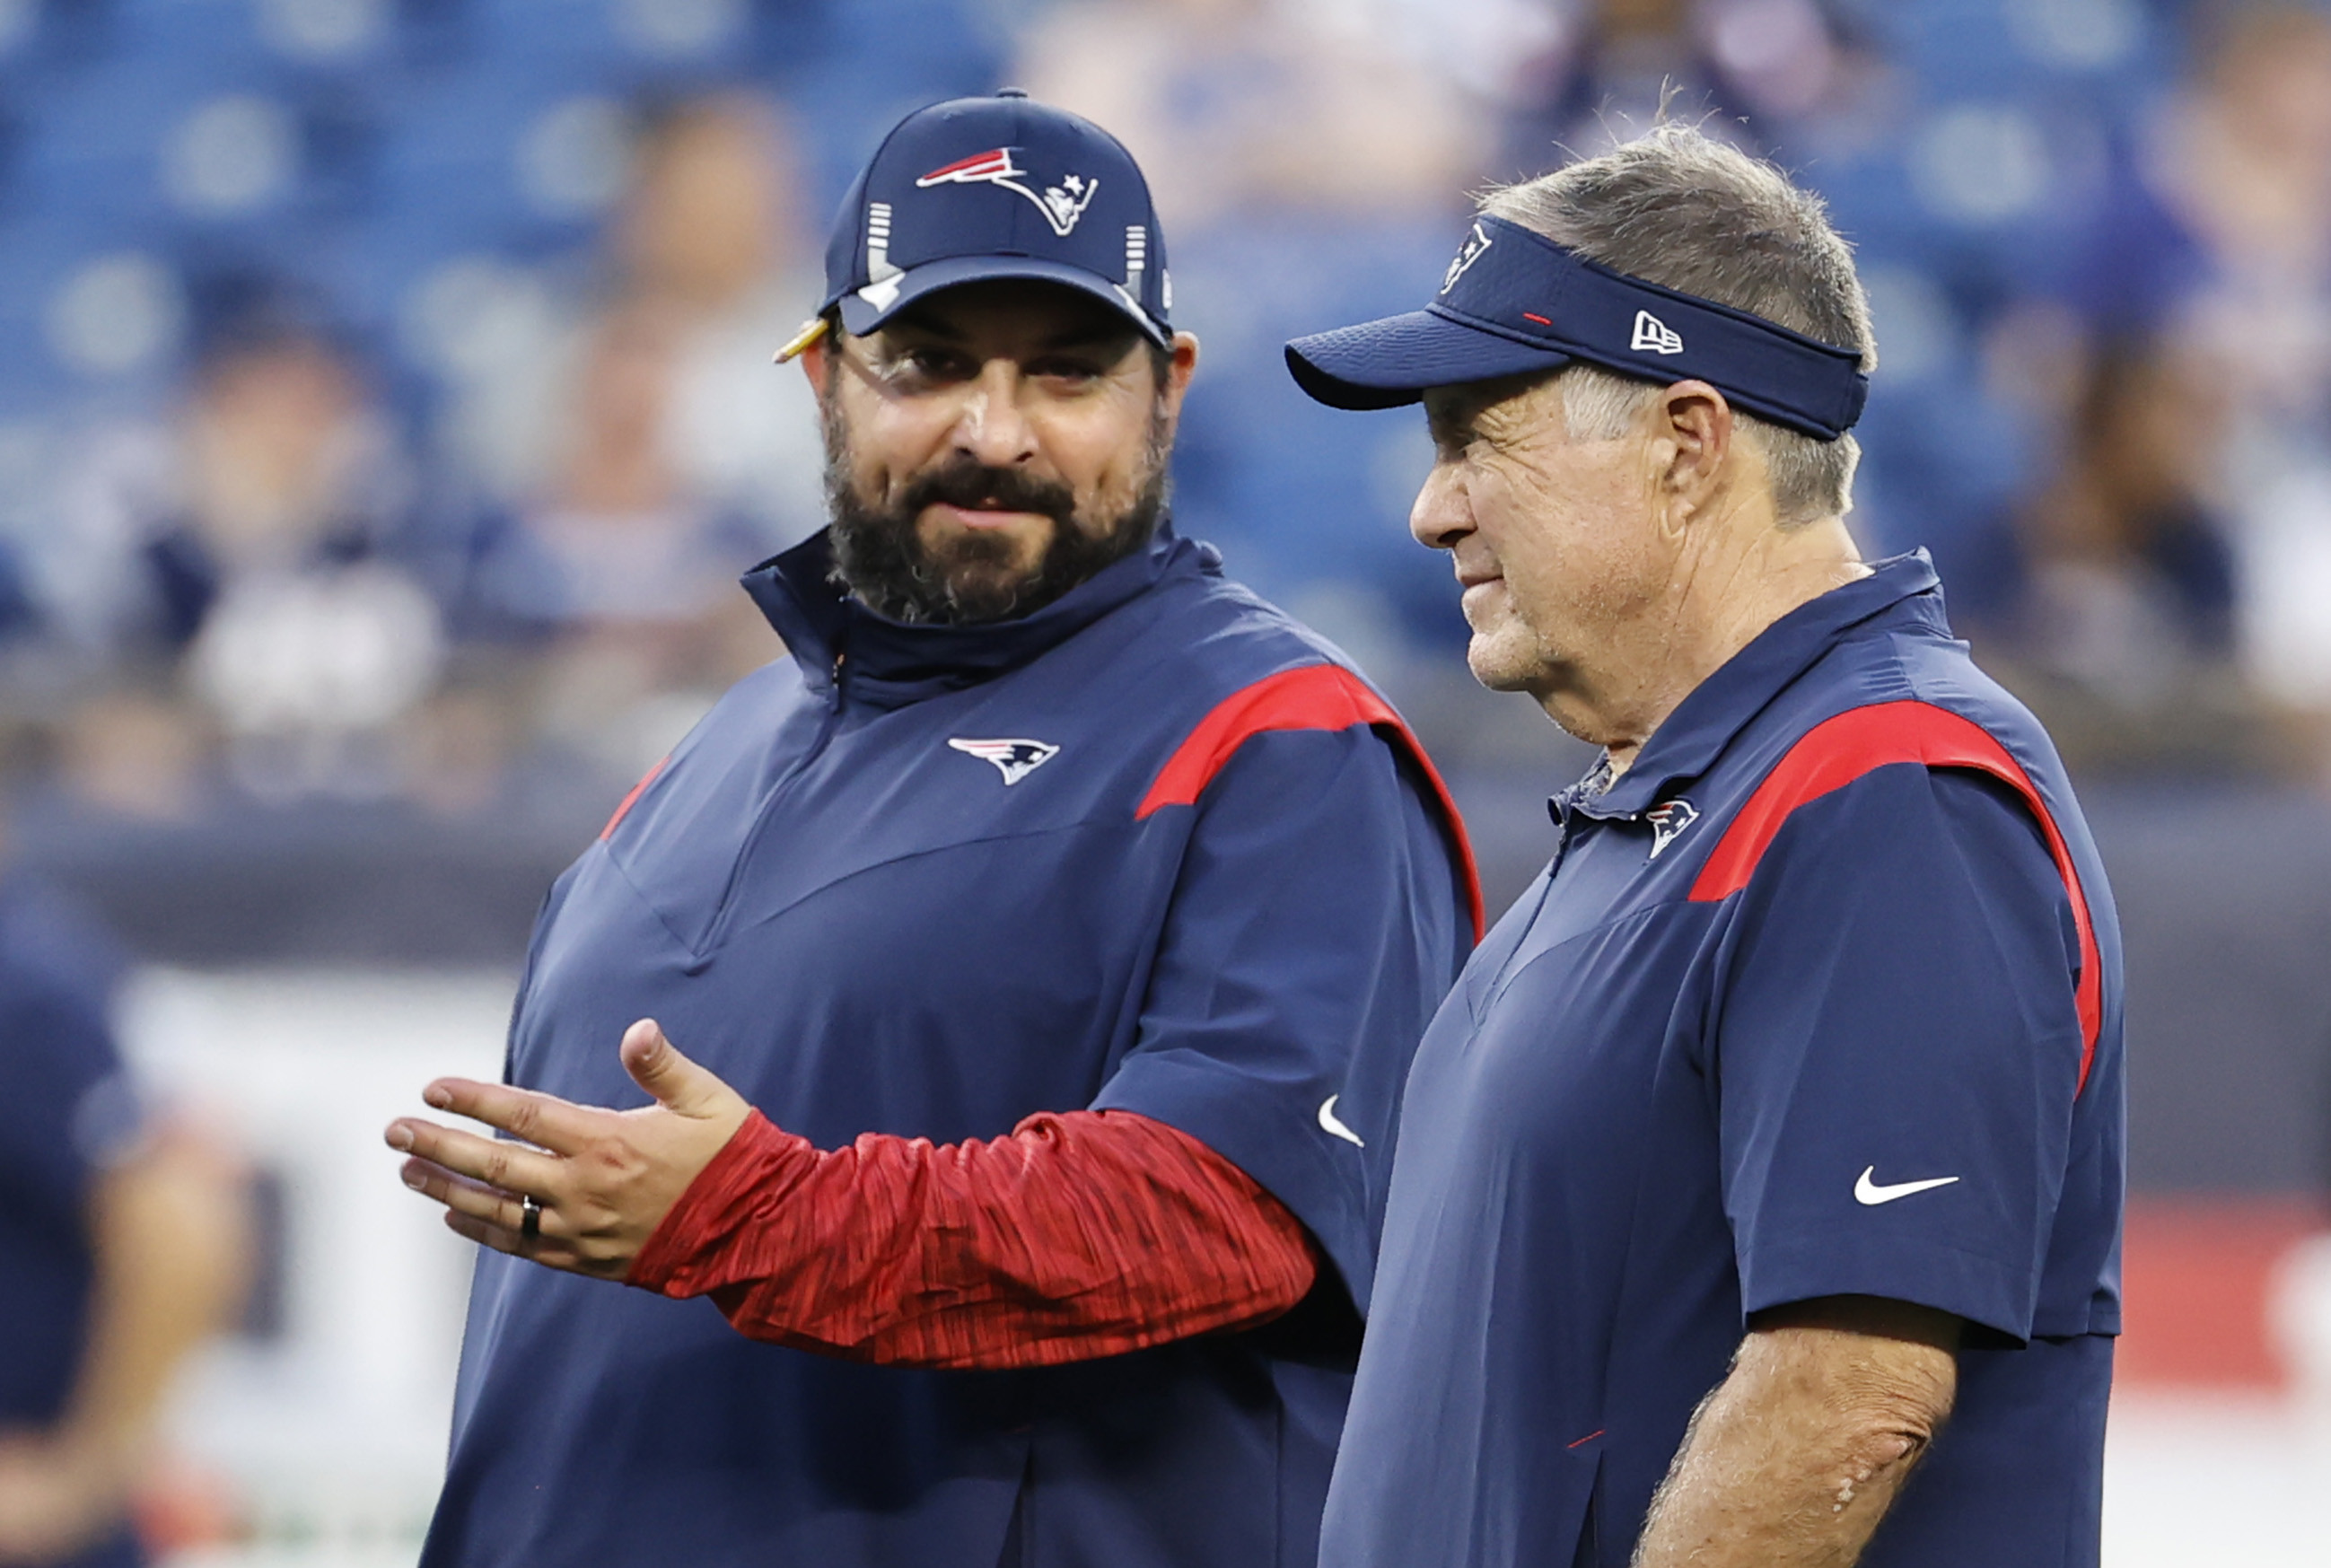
0, 876, 145, 1568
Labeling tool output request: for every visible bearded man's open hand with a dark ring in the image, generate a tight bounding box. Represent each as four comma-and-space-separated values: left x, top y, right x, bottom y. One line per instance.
387, 1018, 753, 1279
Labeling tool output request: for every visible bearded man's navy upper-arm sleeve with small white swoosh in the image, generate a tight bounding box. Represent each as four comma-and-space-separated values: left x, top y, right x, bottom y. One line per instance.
1093, 724, 1473, 1311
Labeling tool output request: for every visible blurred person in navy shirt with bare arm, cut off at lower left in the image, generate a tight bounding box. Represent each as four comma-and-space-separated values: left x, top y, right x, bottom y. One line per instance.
0, 876, 251, 1568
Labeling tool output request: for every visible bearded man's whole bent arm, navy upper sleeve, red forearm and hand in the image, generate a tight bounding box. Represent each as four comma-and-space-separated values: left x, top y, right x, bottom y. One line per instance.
390, 727, 1467, 1368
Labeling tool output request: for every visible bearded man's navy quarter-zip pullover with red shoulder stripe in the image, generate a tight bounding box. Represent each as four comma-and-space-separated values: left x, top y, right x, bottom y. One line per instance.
425, 531, 1477, 1568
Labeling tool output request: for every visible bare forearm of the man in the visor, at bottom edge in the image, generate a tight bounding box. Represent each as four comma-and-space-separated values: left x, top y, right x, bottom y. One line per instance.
1634, 1295, 1960, 1568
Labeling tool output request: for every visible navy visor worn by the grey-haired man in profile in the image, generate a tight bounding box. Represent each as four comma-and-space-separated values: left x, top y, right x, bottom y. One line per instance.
1287, 215, 1870, 441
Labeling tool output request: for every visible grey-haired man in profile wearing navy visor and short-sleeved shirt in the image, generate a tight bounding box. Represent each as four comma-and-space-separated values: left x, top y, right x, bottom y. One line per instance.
1289, 126, 2124, 1568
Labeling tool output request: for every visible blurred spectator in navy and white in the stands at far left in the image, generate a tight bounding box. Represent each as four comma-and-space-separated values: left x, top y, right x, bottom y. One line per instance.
49, 301, 443, 813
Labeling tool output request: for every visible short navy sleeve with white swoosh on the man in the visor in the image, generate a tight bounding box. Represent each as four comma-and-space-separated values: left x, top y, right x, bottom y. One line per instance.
1713, 764, 2081, 1340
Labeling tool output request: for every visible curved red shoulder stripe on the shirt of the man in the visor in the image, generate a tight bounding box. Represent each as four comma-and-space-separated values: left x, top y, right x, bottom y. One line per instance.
1692, 701, 2105, 1086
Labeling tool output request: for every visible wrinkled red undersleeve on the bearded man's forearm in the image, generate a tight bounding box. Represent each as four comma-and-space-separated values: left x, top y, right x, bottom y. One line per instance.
629, 1111, 1317, 1368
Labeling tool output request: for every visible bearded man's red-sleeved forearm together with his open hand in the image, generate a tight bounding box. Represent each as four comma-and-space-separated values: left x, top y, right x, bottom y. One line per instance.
390, 1023, 1317, 1368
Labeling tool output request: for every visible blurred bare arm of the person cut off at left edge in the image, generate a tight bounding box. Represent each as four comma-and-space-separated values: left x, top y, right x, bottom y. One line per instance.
0, 1133, 250, 1564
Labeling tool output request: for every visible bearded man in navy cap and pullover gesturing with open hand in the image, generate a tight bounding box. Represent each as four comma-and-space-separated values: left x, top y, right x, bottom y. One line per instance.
390, 93, 1477, 1568
